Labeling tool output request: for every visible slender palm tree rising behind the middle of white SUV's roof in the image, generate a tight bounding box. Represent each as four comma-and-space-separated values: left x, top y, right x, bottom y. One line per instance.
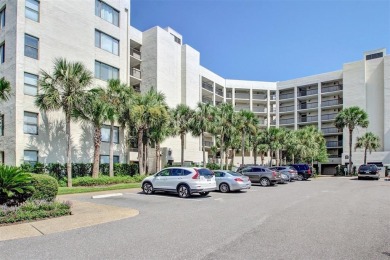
171, 104, 194, 166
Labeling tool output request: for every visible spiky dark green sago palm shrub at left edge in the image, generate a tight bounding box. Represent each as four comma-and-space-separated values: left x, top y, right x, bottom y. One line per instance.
0, 165, 34, 205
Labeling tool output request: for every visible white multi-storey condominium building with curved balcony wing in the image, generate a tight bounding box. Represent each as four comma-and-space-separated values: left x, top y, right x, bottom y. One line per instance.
0, 0, 390, 173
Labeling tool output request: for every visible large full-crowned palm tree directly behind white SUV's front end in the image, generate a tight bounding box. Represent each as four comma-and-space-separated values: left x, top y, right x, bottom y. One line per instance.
124, 88, 167, 175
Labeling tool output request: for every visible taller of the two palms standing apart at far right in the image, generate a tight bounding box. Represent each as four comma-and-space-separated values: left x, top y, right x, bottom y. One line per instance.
335, 106, 369, 174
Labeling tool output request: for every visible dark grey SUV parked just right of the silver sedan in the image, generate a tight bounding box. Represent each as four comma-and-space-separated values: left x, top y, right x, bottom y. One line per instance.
235, 166, 281, 186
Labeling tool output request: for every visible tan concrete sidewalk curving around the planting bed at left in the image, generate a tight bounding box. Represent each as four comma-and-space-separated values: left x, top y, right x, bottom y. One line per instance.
0, 189, 139, 241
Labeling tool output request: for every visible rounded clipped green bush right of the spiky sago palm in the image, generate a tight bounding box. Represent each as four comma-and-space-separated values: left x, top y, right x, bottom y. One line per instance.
30, 174, 58, 201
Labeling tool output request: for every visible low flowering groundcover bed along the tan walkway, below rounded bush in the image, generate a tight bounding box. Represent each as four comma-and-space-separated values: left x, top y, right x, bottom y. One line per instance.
0, 200, 71, 225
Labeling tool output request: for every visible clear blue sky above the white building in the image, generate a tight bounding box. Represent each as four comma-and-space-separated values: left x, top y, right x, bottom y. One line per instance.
131, 0, 390, 81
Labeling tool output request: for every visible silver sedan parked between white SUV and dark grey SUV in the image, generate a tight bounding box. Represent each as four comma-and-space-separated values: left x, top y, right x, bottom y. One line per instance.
214, 170, 252, 193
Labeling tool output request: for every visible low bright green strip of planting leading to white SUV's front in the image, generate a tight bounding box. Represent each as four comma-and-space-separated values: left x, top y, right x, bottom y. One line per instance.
72, 175, 147, 187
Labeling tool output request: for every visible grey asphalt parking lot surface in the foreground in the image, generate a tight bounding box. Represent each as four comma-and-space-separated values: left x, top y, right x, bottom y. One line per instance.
0, 177, 390, 259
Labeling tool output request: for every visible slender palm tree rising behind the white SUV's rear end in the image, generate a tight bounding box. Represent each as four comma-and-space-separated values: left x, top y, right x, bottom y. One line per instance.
190, 102, 213, 167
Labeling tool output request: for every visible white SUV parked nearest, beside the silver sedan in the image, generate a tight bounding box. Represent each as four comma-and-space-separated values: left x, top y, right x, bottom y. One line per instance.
142, 167, 216, 198
